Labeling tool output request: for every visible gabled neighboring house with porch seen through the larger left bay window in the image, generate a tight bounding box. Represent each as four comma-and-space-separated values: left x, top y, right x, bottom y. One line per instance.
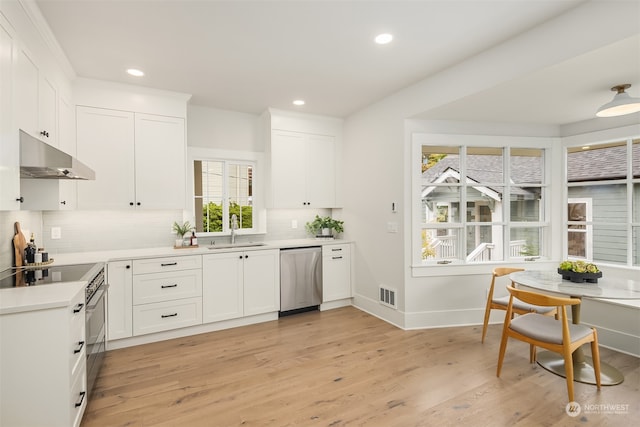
420, 137, 549, 264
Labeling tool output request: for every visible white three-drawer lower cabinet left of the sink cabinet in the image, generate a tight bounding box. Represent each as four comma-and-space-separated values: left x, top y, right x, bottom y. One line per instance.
133, 255, 202, 336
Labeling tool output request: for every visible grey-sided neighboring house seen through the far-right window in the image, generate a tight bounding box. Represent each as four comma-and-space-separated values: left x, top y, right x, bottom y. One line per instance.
566, 139, 640, 266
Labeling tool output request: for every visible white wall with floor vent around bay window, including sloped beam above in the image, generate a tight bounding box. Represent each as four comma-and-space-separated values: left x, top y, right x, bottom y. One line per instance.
343, 2, 637, 327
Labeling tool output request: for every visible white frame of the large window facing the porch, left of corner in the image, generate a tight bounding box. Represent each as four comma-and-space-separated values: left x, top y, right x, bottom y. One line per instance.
410, 132, 558, 277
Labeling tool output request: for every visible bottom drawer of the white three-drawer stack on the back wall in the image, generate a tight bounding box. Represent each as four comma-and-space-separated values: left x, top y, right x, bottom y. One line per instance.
133, 298, 202, 335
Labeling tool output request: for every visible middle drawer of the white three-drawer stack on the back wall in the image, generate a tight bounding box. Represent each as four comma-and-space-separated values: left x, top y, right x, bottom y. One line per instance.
133, 270, 202, 305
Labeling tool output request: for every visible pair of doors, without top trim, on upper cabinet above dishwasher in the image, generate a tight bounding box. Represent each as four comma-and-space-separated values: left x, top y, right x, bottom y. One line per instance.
270, 130, 336, 208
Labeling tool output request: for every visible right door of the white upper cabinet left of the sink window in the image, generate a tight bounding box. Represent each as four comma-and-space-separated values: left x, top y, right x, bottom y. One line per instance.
135, 113, 186, 209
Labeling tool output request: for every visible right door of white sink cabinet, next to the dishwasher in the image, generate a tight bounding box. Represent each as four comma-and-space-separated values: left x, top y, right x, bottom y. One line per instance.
244, 249, 280, 316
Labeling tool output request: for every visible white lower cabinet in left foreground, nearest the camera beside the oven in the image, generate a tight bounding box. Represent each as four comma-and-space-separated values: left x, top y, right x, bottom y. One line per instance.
0, 288, 87, 427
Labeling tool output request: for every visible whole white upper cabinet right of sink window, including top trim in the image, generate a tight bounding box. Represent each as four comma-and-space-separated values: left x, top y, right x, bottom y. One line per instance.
267, 112, 342, 209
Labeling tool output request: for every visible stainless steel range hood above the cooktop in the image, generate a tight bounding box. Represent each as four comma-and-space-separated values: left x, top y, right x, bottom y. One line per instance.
20, 129, 96, 179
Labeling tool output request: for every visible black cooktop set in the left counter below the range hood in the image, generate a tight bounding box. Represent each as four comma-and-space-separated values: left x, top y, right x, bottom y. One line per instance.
0, 263, 96, 289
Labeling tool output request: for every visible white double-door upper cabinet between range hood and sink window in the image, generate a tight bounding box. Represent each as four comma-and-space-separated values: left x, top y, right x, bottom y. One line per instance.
77, 106, 186, 209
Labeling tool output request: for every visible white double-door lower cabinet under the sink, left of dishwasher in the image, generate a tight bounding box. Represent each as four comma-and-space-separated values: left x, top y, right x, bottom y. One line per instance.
202, 249, 280, 323
